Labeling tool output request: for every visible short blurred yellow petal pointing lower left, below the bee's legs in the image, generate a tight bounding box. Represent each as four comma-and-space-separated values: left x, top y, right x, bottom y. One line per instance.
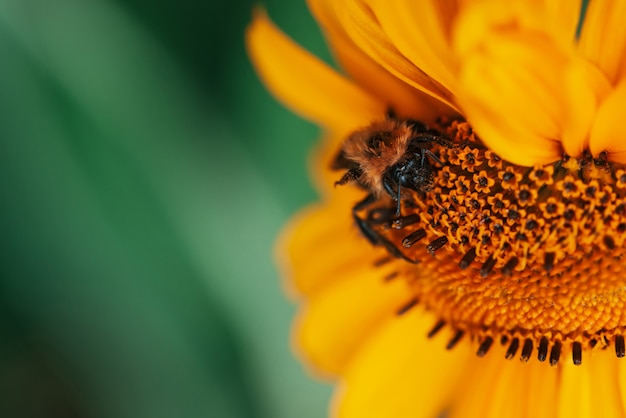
294, 256, 411, 375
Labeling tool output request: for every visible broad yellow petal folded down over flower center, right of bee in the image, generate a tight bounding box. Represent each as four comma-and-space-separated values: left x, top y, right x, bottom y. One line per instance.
454, 2, 573, 165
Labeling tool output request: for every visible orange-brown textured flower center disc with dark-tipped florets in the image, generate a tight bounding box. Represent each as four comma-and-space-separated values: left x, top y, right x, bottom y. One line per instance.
339, 118, 626, 365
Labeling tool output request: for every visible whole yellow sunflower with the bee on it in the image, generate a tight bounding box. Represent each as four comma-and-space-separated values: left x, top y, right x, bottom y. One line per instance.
247, 0, 626, 418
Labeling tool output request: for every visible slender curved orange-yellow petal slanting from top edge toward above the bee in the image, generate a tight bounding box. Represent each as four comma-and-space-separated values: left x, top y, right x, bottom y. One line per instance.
332, 0, 456, 109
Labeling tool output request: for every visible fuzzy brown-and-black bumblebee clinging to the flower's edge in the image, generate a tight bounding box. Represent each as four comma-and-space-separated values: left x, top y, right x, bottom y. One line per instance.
332, 113, 456, 261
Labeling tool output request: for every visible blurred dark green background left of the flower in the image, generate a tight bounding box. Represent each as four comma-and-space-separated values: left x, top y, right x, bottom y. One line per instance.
0, 0, 331, 418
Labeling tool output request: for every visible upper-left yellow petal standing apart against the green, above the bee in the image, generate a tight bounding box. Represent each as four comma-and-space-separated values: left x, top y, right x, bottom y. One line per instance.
246, 11, 385, 130
